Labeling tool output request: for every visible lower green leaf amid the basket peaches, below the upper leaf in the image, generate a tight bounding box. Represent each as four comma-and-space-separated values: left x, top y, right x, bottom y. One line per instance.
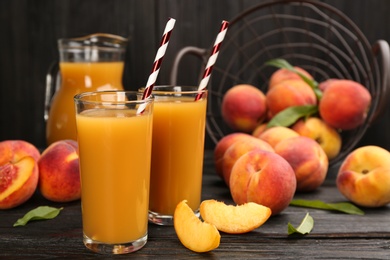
267, 105, 318, 127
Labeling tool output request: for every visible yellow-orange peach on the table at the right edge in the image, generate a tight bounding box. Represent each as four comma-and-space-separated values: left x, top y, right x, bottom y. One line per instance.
336, 145, 390, 207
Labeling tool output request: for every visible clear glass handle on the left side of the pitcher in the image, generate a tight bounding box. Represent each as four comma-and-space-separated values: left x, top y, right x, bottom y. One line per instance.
43, 61, 60, 122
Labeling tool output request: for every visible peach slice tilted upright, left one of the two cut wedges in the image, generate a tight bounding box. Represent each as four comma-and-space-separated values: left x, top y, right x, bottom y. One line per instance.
173, 200, 221, 253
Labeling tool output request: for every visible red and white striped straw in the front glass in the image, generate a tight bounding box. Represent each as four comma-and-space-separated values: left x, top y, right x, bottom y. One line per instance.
138, 18, 176, 113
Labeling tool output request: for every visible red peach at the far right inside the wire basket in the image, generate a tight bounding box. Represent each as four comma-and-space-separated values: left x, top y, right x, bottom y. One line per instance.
319, 79, 371, 130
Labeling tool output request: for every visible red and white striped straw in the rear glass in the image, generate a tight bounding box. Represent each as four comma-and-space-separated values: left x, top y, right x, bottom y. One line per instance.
195, 21, 229, 100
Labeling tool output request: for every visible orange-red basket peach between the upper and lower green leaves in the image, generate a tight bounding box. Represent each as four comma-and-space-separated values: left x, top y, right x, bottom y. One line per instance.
266, 79, 317, 117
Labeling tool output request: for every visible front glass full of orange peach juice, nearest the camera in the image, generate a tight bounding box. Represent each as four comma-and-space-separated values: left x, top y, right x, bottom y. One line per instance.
74, 91, 154, 254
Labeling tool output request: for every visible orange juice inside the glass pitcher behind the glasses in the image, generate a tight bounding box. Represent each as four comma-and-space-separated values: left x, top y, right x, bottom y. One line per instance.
46, 62, 124, 145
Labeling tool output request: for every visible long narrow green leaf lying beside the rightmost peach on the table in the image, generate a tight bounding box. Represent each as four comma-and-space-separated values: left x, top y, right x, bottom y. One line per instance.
290, 199, 364, 215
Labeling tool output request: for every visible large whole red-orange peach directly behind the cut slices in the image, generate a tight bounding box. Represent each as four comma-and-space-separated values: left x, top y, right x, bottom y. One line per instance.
230, 149, 297, 215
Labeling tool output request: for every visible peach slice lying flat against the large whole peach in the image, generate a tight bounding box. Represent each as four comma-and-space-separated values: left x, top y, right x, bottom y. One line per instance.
200, 200, 272, 234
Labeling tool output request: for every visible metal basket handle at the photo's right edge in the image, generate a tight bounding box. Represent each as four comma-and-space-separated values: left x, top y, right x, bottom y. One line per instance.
370, 40, 390, 124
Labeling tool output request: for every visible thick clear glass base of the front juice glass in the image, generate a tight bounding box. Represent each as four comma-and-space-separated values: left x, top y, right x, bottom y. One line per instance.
83, 234, 148, 255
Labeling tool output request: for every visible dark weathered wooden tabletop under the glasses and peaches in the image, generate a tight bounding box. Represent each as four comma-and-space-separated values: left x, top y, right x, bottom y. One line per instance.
0, 151, 390, 259
